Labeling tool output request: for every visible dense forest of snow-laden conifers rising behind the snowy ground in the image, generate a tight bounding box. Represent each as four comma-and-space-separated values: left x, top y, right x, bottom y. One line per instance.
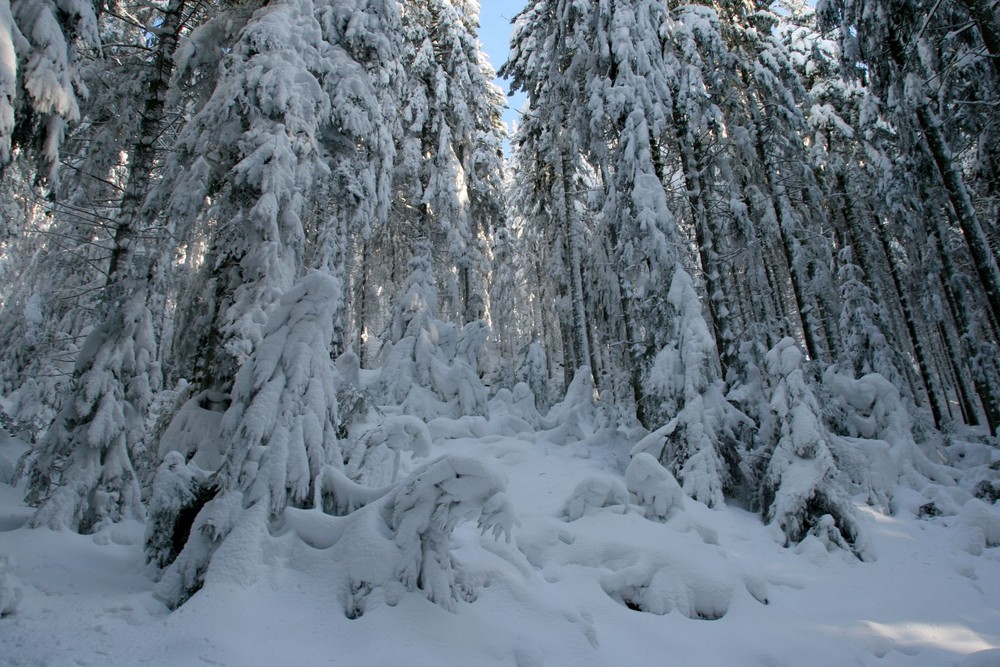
0, 0, 1000, 605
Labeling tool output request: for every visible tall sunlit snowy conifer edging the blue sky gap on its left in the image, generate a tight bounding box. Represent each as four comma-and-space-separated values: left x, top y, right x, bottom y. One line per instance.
396, 0, 503, 323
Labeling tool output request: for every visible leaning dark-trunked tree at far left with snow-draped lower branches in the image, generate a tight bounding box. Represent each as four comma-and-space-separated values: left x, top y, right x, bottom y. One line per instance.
16, 0, 200, 532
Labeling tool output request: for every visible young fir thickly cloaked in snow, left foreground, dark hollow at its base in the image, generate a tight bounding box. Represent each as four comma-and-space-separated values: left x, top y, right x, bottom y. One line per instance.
152, 271, 343, 606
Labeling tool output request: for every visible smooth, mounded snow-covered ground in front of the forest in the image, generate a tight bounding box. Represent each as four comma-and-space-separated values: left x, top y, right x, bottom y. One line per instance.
0, 428, 1000, 667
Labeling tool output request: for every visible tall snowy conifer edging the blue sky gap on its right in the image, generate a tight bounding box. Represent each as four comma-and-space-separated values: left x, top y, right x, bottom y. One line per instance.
500, 0, 600, 387
